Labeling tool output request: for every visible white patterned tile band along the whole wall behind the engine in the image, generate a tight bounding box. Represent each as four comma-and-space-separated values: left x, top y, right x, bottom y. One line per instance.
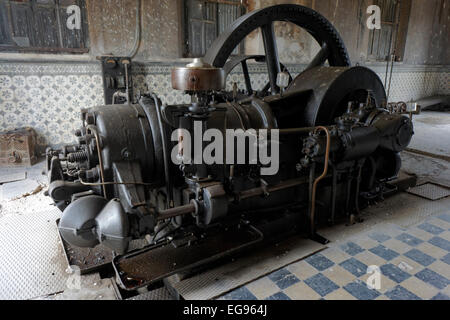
0, 61, 450, 149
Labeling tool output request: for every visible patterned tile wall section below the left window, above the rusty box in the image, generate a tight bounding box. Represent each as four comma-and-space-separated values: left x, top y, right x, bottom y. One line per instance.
0, 63, 103, 149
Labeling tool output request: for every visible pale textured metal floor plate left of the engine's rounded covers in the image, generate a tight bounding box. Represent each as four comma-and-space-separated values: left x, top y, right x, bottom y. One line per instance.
0, 208, 69, 300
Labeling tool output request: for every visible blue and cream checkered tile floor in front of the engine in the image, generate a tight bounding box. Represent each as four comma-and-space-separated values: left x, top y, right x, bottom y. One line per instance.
220, 214, 450, 300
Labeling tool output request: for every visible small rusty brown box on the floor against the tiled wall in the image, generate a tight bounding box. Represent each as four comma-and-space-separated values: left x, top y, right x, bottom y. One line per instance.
0, 127, 37, 167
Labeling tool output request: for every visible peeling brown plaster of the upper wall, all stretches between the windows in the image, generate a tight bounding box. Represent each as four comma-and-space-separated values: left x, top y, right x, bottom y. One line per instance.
0, 0, 450, 65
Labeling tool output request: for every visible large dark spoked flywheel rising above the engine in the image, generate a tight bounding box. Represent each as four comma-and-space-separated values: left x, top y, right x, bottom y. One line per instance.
205, 4, 350, 94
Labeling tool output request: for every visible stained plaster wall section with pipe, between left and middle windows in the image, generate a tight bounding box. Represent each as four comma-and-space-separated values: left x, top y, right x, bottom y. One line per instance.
87, 0, 182, 61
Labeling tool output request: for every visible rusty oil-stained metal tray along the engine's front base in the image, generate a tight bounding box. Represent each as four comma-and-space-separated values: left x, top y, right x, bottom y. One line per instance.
113, 227, 263, 290
